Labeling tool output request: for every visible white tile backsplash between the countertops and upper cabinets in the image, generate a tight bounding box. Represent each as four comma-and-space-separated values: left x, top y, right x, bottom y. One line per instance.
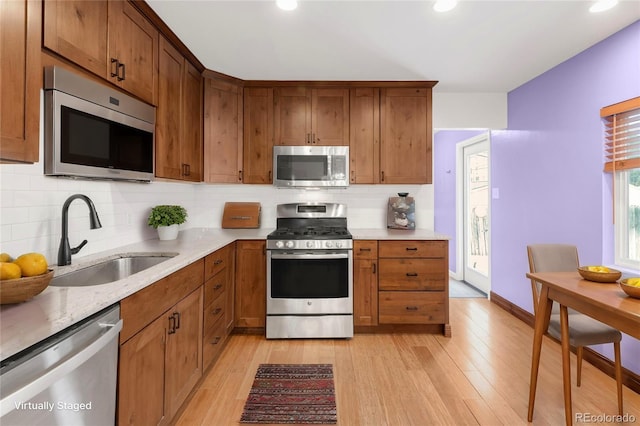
0, 165, 433, 264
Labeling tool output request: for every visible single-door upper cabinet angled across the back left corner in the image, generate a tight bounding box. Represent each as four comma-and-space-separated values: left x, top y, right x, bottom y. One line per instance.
204, 78, 242, 183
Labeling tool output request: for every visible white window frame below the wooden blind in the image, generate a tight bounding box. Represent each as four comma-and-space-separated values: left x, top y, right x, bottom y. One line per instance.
614, 169, 640, 270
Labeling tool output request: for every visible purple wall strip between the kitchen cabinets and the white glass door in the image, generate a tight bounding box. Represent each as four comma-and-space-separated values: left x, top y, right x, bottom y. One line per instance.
433, 130, 486, 273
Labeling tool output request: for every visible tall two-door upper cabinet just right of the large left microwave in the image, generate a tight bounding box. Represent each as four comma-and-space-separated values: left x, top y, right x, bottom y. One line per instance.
155, 38, 203, 182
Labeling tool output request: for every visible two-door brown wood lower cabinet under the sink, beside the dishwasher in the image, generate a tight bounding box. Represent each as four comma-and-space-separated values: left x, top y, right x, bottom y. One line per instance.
118, 260, 204, 425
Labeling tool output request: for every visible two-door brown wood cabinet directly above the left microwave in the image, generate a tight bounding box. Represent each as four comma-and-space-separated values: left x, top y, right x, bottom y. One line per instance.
43, 0, 158, 105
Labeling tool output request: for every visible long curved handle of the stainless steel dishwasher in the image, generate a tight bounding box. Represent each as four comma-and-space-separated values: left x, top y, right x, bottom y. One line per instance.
0, 320, 122, 417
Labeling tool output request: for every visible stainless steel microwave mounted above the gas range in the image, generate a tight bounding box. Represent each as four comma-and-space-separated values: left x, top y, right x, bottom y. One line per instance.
273, 145, 349, 188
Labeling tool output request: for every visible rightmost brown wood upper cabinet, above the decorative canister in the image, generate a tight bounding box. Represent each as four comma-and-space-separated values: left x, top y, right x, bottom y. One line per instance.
380, 88, 432, 184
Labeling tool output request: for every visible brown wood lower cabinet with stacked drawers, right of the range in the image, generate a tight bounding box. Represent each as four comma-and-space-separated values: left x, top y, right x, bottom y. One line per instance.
353, 240, 451, 336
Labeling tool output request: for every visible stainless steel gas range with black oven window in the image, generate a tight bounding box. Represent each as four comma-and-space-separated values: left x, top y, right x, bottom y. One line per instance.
266, 203, 353, 339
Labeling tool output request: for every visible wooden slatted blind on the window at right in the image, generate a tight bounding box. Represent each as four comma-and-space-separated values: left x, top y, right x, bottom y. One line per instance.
600, 96, 640, 172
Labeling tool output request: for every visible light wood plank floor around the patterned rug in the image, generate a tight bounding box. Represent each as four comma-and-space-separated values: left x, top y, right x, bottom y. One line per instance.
177, 298, 640, 426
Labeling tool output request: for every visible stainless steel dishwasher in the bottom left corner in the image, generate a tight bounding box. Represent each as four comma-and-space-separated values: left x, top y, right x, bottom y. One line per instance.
0, 305, 122, 426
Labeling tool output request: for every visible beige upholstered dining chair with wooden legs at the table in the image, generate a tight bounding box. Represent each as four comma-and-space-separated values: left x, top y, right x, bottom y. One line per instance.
527, 244, 622, 415
